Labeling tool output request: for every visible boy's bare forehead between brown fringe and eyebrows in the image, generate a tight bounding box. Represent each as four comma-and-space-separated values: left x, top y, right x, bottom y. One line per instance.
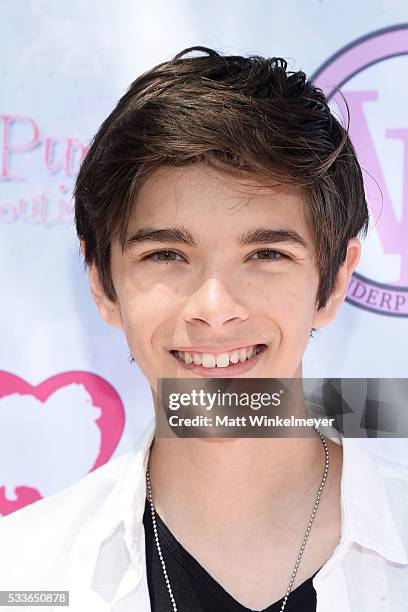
127, 164, 311, 242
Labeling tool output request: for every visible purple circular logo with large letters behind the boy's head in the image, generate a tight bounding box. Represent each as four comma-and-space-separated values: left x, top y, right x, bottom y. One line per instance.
311, 24, 408, 317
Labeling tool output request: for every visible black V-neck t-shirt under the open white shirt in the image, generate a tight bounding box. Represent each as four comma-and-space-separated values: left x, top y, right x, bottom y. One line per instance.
143, 498, 317, 612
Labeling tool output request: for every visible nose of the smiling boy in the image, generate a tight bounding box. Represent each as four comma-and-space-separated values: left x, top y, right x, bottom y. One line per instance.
183, 278, 249, 328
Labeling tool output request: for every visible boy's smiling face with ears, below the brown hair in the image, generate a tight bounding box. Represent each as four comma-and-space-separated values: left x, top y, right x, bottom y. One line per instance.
89, 165, 360, 388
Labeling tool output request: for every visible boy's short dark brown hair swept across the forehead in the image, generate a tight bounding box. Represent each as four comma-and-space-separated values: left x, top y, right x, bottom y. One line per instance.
74, 47, 369, 308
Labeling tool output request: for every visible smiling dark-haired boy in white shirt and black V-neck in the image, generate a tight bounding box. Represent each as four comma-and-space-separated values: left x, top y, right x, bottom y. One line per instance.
0, 47, 408, 612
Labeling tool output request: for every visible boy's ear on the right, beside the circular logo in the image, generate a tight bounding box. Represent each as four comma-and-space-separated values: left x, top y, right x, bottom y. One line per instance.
312, 238, 361, 328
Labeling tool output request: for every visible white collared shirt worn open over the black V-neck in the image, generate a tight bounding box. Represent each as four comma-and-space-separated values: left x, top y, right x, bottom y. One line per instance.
0, 418, 408, 612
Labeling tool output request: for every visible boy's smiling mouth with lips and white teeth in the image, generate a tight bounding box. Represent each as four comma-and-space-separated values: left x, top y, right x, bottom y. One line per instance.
170, 344, 267, 378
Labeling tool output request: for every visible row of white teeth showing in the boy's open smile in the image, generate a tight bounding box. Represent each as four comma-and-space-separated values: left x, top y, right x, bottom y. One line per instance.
170, 344, 267, 370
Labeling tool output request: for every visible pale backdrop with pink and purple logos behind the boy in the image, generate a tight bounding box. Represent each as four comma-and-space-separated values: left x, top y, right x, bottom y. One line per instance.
0, 0, 408, 515
